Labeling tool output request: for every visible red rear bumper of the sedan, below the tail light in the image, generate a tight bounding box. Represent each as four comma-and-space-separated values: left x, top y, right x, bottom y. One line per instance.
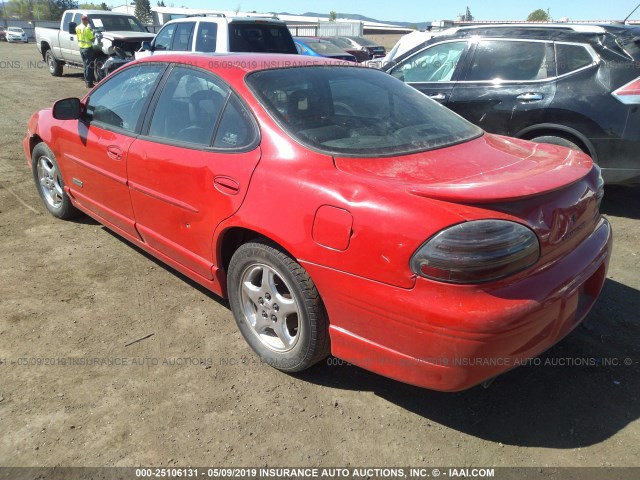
303, 218, 612, 391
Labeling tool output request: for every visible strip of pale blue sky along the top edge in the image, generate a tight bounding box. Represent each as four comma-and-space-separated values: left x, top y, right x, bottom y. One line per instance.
170, 0, 640, 22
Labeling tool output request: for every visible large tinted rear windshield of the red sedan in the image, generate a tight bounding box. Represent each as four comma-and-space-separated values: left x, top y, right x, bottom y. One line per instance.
247, 66, 483, 157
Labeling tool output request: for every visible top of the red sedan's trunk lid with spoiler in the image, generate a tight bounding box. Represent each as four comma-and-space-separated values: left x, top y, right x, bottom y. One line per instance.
334, 134, 592, 204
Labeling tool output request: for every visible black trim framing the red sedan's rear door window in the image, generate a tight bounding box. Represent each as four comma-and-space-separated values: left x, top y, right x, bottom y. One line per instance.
136, 62, 262, 154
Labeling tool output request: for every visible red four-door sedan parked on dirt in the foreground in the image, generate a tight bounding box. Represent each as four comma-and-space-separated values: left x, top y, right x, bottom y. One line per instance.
24, 55, 612, 391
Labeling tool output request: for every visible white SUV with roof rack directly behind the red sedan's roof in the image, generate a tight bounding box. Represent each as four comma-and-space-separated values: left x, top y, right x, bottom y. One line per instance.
136, 15, 298, 58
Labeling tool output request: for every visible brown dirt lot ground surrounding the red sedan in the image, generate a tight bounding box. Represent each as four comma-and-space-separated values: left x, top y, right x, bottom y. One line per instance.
0, 43, 640, 474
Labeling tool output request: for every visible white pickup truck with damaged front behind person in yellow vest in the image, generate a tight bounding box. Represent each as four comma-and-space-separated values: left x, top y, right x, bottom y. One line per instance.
36, 10, 155, 79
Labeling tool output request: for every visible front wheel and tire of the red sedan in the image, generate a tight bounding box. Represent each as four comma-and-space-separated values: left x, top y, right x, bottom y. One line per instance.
31, 143, 78, 219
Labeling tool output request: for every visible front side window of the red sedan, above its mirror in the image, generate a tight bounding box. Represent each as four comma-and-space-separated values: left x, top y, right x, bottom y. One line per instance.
84, 65, 165, 133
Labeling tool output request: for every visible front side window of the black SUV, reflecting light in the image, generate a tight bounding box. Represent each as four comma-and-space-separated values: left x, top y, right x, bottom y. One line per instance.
391, 42, 467, 83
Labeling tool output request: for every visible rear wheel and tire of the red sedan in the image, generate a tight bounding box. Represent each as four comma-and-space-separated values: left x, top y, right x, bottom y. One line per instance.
228, 241, 330, 372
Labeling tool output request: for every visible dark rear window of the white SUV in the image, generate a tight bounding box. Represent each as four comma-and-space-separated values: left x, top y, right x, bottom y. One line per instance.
229, 22, 298, 54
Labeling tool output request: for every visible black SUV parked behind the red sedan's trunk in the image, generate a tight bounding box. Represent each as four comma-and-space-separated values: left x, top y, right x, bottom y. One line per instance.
384, 24, 640, 183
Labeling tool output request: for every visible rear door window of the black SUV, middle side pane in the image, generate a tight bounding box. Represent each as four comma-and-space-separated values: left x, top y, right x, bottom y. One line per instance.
466, 40, 555, 81
